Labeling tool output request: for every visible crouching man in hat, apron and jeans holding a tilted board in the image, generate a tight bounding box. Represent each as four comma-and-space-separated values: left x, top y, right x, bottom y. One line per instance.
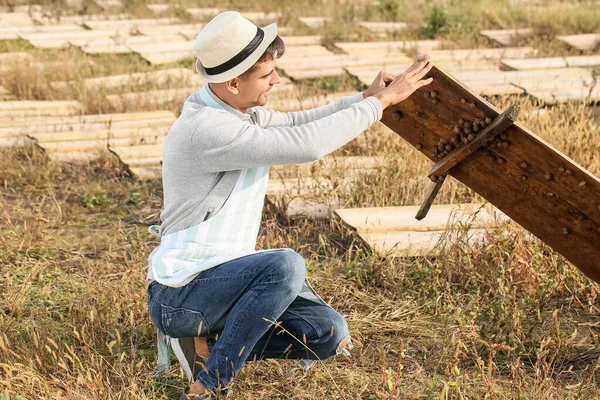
148, 11, 432, 399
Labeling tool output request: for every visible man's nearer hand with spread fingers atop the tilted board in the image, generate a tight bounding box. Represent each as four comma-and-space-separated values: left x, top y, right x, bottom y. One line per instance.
365, 54, 433, 109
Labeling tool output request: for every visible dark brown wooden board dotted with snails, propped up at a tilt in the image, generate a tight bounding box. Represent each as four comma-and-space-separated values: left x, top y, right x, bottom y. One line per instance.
382, 67, 600, 281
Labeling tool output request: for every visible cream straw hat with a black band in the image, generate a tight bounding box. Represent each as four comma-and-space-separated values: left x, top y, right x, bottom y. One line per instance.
194, 11, 277, 83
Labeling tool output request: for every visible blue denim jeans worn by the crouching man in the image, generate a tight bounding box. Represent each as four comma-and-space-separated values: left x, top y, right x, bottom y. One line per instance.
148, 249, 350, 392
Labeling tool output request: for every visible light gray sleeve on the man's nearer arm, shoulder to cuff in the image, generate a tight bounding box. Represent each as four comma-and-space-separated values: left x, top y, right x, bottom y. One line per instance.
190, 97, 383, 173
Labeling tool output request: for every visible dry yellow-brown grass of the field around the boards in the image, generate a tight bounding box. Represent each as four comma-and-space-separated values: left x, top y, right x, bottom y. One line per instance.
0, 0, 600, 400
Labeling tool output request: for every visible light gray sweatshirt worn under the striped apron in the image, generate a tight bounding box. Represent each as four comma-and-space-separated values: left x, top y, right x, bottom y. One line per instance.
160, 83, 383, 235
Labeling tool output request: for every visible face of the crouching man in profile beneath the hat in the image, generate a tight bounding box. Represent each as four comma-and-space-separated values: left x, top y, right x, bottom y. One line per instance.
236, 60, 281, 108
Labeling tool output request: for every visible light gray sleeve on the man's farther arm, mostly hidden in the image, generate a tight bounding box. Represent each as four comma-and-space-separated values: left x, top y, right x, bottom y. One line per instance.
254, 92, 364, 128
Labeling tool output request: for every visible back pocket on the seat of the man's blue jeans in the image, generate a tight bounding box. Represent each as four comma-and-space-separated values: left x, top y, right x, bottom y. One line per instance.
161, 304, 210, 338
